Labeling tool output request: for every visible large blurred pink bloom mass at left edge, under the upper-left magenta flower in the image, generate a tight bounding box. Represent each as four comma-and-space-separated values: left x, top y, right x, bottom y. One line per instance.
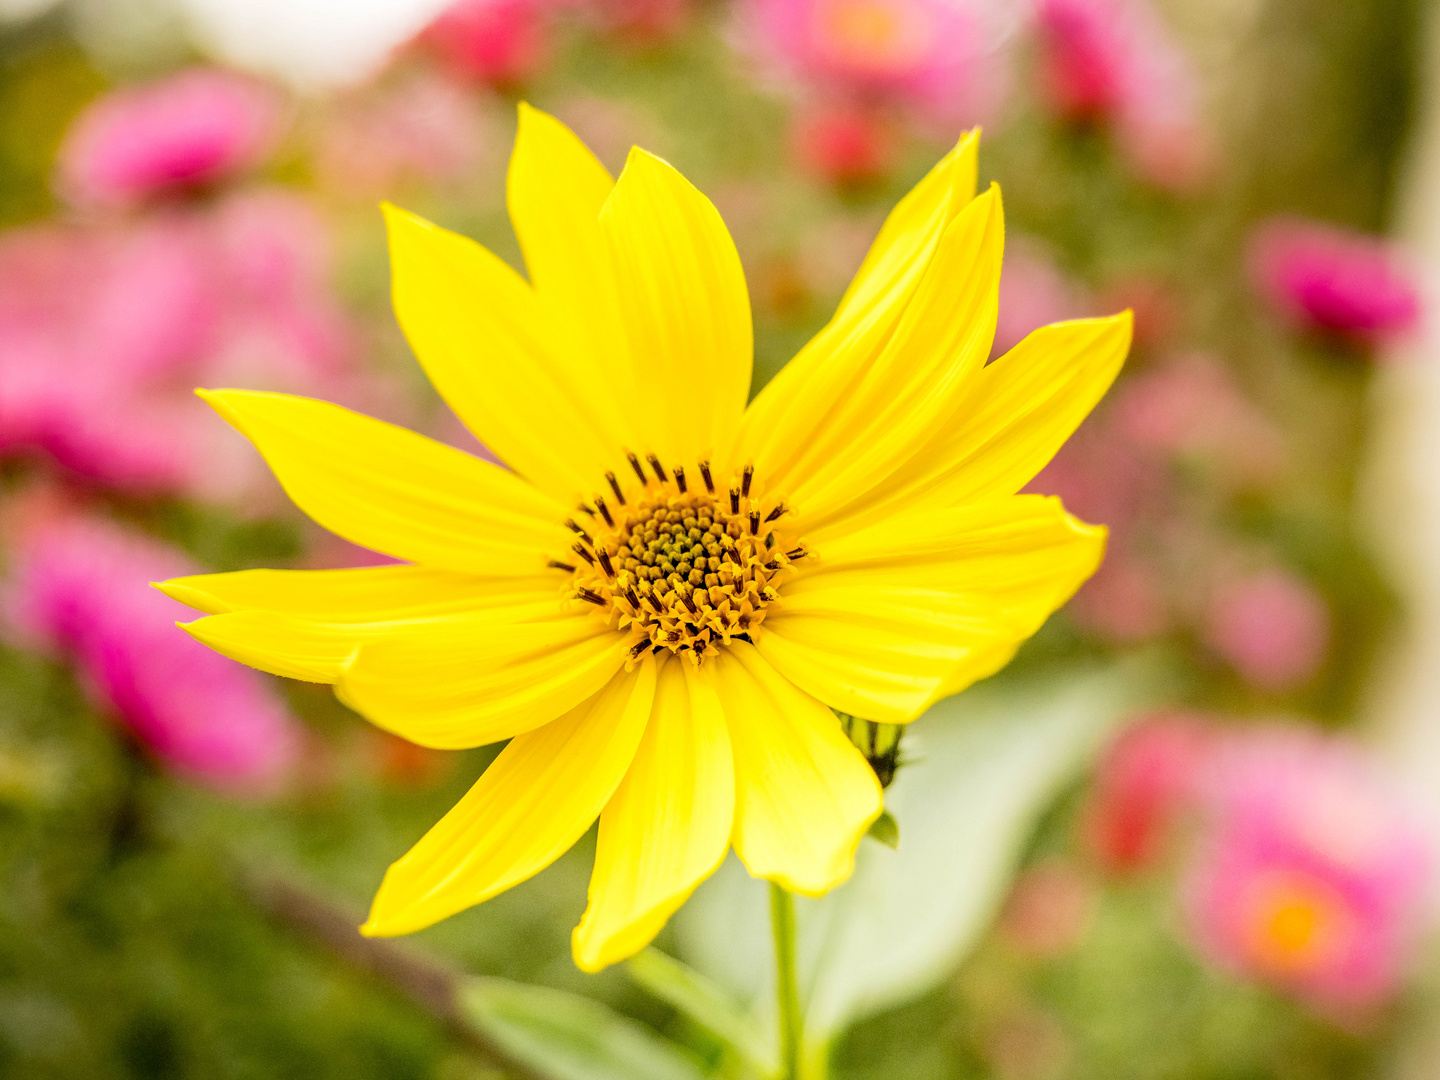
0, 190, 353, 497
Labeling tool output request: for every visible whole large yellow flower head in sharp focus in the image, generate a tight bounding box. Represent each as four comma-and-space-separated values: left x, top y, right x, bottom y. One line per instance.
161, 107, 1130, 971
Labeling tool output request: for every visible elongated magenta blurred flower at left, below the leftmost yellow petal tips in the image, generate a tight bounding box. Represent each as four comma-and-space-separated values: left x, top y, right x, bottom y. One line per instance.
6, 506, 300, 792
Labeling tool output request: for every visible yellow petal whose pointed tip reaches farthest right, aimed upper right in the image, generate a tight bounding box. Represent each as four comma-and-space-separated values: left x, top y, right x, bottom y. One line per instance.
829, 311, 1133, 527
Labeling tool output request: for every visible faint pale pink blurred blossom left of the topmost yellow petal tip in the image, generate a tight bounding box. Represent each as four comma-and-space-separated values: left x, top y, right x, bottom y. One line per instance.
315, 73, 482, 199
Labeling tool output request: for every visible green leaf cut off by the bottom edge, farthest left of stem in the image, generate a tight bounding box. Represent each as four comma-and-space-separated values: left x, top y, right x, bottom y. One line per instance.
461, 978, 704, 1080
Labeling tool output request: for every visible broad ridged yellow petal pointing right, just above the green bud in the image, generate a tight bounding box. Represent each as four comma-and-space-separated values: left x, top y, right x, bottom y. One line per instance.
755, 495, 1104, 723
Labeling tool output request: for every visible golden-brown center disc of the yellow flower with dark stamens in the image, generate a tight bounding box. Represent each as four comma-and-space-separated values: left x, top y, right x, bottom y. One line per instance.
550, 454, 805, 664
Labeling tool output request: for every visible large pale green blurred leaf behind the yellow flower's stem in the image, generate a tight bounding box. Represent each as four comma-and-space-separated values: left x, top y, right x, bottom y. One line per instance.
674, 657, 1164, 1043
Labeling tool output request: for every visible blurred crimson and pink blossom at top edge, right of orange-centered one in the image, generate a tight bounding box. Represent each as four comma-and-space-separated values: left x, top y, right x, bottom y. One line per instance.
1037, 0, 1212, 189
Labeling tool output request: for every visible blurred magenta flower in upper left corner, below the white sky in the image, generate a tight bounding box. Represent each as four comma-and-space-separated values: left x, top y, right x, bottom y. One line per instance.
56, 68, 282, 207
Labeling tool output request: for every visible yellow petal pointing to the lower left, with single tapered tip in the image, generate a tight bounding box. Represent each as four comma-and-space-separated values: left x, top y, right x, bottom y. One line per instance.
360, 658, 655, 937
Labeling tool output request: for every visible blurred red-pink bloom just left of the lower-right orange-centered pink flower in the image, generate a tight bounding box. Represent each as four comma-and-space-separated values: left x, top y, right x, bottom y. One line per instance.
1086, 713, 1212, 873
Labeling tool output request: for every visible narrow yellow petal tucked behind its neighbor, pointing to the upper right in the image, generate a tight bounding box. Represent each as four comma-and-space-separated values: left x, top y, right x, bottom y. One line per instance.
733, 131, 979, 491
